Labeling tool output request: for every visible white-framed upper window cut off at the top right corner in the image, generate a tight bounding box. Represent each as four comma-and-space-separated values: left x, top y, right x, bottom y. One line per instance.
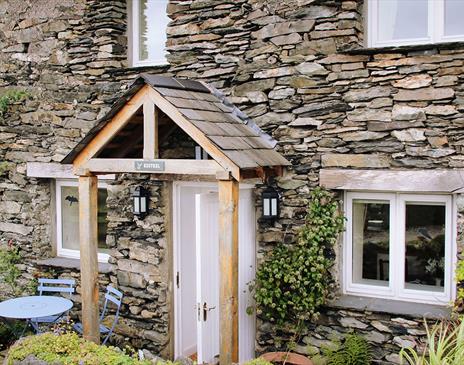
367, 0, 464, 47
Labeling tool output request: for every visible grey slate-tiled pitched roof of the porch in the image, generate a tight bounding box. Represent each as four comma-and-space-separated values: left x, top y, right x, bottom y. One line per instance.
62, 74, 291, 169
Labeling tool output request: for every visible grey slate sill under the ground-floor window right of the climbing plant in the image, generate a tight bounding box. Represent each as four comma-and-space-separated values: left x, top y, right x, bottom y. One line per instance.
328, 295, 451, 319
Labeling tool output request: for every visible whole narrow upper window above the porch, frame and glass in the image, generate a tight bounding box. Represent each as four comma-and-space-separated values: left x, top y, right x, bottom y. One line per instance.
128, 0, 169, 66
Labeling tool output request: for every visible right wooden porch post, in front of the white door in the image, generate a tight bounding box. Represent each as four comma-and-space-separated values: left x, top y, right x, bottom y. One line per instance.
218, 180, 239, 365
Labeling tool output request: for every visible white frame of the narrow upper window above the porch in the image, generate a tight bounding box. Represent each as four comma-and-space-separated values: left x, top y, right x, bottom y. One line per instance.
128, 0, 169, 67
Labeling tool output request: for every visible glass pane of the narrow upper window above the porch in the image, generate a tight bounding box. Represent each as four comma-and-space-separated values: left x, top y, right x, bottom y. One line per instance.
139, 0, 169, 62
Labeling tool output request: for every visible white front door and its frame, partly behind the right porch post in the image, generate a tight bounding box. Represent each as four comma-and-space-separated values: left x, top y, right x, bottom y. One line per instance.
174, 183, 256, 364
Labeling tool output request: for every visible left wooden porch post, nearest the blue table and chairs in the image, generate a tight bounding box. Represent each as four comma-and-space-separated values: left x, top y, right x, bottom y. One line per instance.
79, 176, 100, 343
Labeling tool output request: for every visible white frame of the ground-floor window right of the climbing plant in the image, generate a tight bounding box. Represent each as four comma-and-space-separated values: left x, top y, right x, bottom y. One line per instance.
342, 191, 457, 305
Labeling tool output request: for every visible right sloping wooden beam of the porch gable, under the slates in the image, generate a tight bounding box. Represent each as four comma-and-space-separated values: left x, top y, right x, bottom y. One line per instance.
148, 88, 240, 181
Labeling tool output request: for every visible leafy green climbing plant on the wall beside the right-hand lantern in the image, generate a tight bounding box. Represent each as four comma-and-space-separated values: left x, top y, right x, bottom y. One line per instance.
255, 188, 344, 325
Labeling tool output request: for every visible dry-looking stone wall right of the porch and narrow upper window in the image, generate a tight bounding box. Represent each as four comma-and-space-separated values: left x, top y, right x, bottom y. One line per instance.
168, 1, 464, 363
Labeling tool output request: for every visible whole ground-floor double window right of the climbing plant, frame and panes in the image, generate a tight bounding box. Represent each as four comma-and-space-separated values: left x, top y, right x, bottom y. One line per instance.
343, 192, 455, 304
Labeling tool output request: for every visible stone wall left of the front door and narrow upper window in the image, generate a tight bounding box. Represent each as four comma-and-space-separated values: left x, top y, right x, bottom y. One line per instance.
0, 0, 169, 354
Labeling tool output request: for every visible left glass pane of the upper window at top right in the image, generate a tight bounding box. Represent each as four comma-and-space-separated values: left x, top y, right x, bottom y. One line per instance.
377, 0, 428, 41
